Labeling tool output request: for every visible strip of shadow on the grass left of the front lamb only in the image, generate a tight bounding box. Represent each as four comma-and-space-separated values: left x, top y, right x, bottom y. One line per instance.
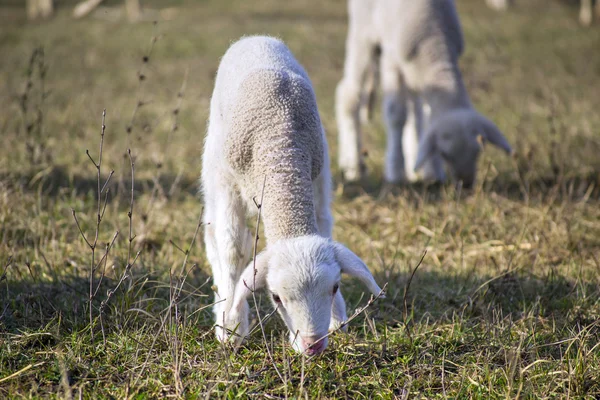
0, 261, 213, 333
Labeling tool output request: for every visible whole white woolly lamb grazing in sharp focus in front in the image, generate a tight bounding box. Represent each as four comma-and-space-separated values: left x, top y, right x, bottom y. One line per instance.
201, 36, 381, 355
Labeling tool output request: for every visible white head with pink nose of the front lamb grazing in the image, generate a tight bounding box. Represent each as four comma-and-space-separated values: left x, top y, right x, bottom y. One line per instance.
227, 235, 381, 355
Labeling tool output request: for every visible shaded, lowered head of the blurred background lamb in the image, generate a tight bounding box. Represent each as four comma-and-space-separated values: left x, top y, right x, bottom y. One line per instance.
415, 109, 512, 187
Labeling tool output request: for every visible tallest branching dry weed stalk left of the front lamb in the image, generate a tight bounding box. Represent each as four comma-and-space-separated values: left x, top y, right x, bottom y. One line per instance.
71, 109, 119, 340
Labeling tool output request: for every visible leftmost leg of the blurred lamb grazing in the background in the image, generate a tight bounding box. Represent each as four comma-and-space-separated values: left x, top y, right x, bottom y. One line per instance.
335, 25, 374, 182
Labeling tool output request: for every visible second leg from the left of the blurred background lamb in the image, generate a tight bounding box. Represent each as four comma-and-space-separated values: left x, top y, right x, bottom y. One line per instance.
381, 52, 408, 183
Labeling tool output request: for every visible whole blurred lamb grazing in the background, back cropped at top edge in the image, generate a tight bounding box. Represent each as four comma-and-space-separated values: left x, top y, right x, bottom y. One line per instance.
336, 0, 511, 186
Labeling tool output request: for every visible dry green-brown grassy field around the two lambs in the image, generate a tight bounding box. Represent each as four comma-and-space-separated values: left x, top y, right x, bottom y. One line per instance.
0, 0, 600, 399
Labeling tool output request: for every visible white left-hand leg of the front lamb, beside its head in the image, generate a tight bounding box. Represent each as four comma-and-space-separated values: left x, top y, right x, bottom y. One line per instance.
203, 176, 252, 341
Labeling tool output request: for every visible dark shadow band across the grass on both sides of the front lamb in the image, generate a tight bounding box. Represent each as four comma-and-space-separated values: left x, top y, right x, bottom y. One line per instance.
0, 260, 600, 335
